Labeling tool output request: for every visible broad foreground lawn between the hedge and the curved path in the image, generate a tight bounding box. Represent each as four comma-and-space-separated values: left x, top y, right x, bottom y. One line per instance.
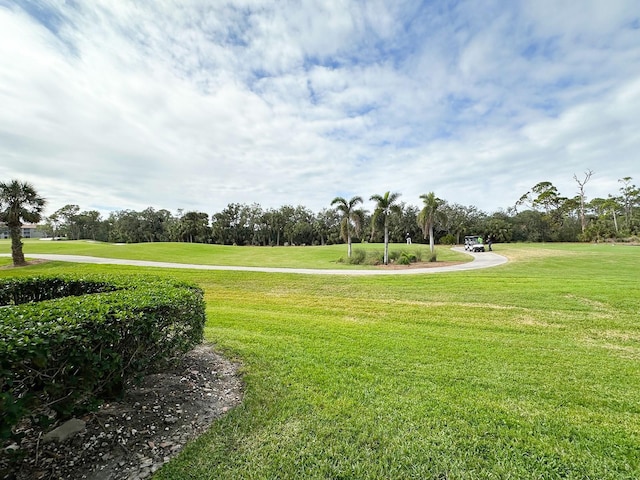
0, 245, 640, 479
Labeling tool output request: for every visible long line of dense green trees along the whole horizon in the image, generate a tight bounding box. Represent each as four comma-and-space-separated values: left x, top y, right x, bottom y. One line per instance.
26, 171, 640, 246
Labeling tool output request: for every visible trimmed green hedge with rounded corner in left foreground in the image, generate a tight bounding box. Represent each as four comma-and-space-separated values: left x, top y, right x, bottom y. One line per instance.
0, 276, 205, 439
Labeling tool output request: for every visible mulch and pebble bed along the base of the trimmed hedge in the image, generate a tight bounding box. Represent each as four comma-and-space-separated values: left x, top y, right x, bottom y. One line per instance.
0, 345, 243, 480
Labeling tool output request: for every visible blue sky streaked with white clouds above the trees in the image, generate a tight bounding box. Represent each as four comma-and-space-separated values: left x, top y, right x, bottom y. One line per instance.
0, 0, 640, 215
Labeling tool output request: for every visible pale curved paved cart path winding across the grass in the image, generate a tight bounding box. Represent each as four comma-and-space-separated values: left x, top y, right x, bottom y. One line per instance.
0, 247, 507, 275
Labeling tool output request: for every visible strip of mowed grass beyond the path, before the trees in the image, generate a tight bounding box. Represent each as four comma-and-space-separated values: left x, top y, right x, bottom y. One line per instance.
0, 240, 469, 269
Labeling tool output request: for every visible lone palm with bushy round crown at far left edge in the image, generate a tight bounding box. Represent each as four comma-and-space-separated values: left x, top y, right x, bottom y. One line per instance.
0, 180, 46, 266
